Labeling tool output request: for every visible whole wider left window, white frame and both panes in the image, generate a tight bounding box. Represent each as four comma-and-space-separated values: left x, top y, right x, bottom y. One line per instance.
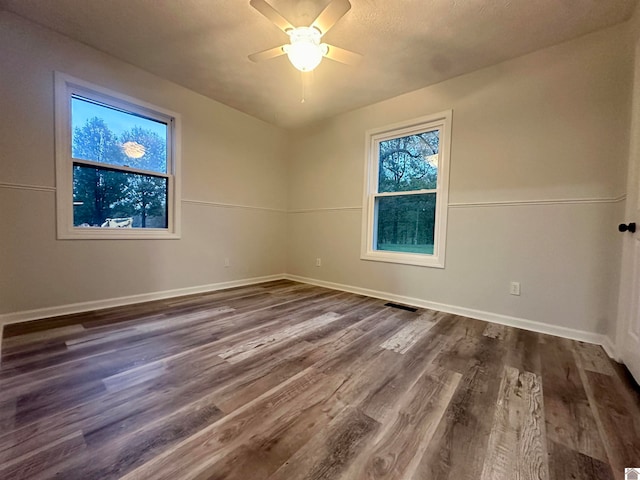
55, 73, 180, 239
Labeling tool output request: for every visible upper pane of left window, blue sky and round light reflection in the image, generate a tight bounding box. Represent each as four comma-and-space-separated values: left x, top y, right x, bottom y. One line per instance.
71, 95, 167, 173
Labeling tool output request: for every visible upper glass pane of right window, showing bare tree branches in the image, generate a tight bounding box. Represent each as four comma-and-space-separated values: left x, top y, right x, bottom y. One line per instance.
378, 130, 440, 193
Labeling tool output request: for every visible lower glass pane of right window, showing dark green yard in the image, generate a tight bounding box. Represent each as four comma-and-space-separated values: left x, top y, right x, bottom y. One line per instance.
374, 193, 436, 255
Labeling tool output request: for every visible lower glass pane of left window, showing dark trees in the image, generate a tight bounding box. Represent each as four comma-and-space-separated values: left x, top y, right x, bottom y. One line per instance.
73, 164, 168, 228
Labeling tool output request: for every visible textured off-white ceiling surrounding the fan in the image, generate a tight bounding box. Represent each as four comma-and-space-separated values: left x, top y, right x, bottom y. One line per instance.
0, 0, 636, 127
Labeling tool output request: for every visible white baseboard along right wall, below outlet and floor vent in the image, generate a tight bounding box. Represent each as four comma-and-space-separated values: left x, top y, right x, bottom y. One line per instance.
285, 274, 615, 350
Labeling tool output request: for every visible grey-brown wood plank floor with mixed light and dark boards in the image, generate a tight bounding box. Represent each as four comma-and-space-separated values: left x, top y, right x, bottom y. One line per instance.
0, 281, 640, 480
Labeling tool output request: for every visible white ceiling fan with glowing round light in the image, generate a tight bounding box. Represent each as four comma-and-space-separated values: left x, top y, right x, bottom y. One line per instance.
249, 0, 362, 72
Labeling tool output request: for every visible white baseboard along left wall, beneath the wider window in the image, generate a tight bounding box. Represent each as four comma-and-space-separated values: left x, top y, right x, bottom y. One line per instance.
0, 274, 285, 328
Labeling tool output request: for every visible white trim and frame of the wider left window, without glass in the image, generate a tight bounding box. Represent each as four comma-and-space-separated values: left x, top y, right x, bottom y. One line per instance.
54, 72, 182, 240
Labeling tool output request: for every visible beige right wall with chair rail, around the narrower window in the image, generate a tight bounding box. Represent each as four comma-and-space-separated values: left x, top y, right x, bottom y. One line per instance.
287, 25, 632, 333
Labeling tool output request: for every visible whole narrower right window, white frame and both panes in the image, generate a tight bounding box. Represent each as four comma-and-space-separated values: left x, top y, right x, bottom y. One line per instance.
361, 111, 452, 268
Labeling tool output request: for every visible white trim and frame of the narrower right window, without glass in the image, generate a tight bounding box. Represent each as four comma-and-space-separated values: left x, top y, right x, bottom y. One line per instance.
360, 110, 453, 268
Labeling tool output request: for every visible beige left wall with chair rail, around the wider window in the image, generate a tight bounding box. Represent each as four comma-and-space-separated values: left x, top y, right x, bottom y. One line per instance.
0, 12, 287, 314
